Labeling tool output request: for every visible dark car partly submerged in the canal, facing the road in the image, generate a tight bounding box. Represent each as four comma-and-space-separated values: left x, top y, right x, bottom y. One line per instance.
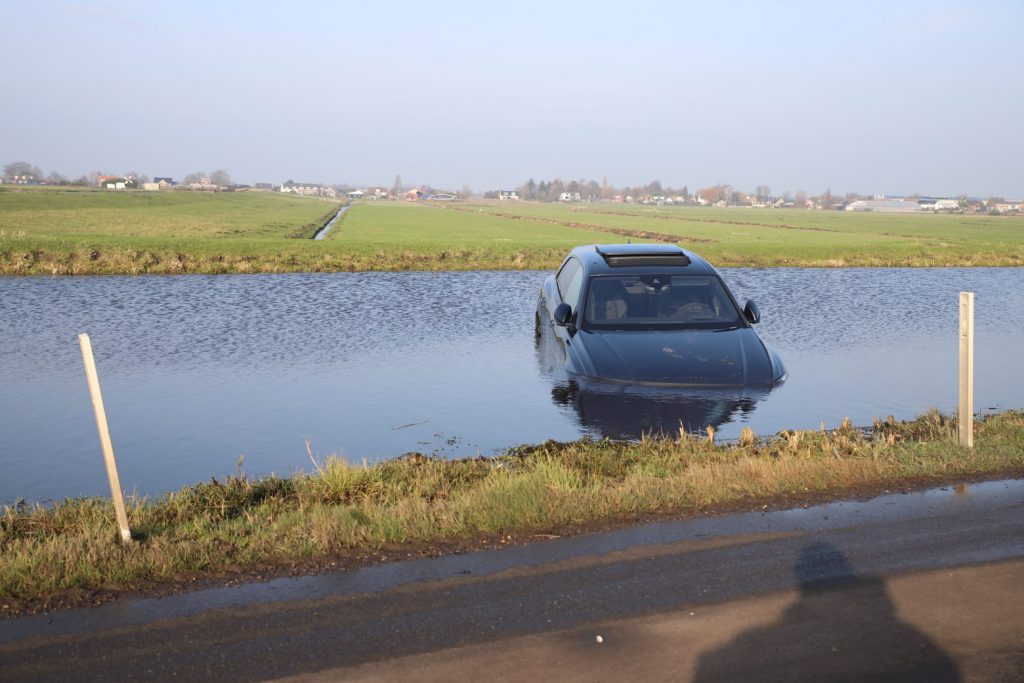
537, 244, 786, 387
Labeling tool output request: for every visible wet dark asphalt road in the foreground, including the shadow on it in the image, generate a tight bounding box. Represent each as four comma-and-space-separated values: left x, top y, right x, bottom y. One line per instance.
0, 481, 1024, 680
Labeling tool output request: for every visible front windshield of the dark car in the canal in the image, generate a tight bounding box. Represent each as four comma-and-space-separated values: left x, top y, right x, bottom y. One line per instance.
584, 274, 741, 330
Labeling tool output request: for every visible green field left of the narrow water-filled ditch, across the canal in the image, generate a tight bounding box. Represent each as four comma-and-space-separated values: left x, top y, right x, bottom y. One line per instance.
0, 188, 338, 274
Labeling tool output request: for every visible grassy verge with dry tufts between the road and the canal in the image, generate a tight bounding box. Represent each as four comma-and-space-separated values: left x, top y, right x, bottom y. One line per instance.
0, 413, 1024, 613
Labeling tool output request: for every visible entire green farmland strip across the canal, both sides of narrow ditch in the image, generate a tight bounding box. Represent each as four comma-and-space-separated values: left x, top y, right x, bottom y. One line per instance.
0, 187, 1024, 274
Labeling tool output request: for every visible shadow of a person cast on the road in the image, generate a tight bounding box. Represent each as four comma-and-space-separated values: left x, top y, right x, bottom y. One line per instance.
694, 543, 961, 682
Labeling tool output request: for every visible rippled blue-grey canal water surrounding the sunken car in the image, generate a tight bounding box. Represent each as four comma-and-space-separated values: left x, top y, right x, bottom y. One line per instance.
0, 268, 1024, 503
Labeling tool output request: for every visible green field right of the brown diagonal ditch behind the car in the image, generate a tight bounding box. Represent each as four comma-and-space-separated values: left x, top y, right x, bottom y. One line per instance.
444, 203, 1024, 267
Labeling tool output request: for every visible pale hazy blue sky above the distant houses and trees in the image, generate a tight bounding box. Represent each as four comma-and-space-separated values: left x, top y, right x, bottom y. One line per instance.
0, 0, 1024, 198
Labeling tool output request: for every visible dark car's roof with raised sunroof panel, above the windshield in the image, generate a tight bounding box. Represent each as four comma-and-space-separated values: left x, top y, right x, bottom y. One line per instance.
570, 244, 716, 275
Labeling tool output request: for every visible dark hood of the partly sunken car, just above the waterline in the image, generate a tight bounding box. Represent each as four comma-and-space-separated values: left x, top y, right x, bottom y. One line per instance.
577, 328, 772, 386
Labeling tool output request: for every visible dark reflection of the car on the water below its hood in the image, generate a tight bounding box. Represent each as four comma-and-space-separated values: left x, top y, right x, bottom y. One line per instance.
551, 378, 771, 439
